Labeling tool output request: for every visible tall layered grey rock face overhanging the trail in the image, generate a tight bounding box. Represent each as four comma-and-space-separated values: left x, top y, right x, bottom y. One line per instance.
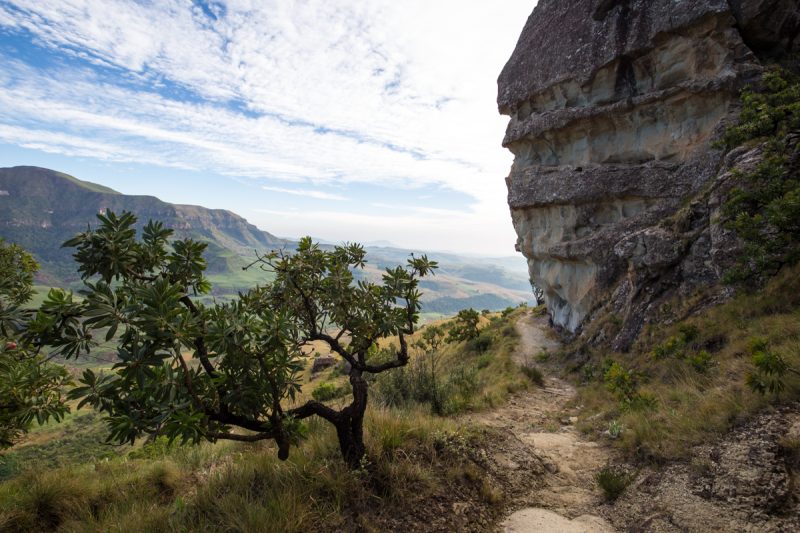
498, 0, 800, 349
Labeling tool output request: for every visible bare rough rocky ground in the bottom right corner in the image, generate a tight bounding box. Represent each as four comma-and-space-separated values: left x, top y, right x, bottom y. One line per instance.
603, 405, 800, 533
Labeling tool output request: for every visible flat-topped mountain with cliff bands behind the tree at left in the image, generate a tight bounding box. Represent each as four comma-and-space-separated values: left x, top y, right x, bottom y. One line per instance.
0, 167, 287, 284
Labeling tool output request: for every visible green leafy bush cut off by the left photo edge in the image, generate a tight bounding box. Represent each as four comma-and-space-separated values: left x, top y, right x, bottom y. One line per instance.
0, 240, 70, 448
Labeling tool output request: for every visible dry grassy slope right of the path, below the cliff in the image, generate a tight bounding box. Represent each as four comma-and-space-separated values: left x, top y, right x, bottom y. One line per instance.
572, 265, 800, 461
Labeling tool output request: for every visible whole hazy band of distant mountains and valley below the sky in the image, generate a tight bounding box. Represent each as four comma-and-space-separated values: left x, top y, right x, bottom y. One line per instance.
0, 167, 533, 316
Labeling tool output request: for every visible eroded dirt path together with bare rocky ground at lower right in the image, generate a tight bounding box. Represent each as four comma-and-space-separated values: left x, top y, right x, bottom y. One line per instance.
470, 311, 800, 533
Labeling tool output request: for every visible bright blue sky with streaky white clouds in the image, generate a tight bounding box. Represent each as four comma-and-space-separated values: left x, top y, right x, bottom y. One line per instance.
0, 0, 536, 256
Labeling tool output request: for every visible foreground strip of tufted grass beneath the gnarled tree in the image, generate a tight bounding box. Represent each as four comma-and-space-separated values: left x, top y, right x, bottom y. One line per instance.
0, 408, 494, 532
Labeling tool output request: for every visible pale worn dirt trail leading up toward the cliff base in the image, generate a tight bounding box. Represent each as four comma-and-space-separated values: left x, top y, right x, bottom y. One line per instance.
472, 312, 614, 533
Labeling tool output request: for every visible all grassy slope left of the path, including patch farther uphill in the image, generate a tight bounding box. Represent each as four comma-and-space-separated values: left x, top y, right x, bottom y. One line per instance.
0, 311, 530, 531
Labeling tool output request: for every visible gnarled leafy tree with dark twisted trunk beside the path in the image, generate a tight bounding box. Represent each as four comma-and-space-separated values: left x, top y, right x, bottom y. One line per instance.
31, 213, 436, 467
